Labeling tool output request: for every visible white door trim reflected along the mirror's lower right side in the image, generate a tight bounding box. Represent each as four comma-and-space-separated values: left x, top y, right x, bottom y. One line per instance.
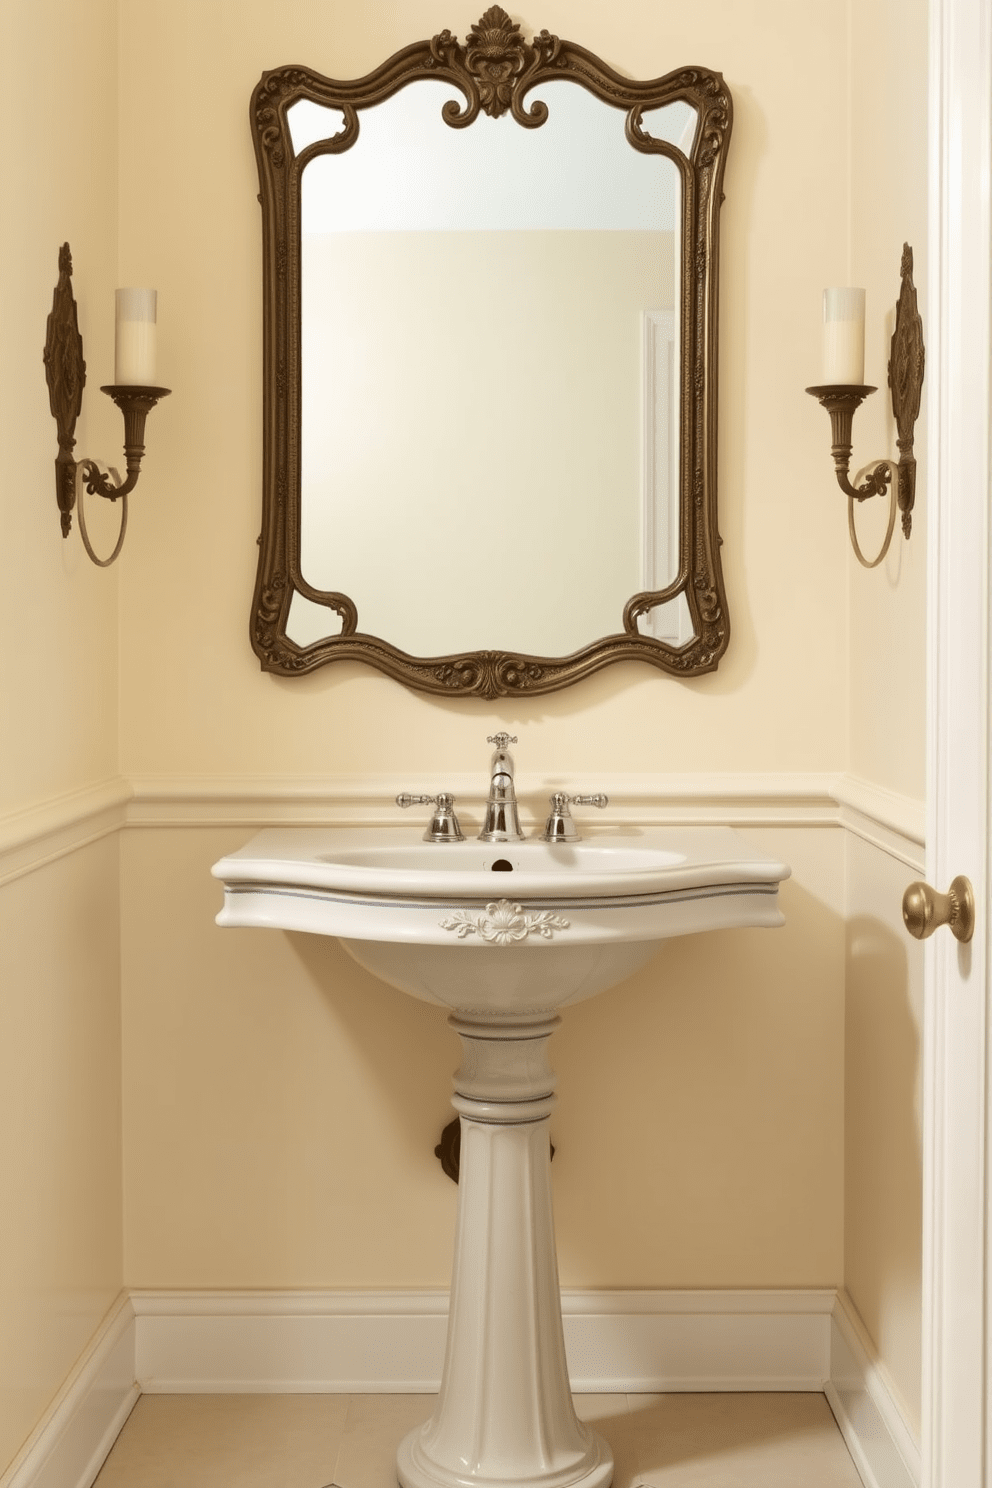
638, 310, 693, 646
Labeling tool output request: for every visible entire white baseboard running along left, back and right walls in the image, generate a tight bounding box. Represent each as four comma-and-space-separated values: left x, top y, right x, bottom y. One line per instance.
0, 1290, 921, 1488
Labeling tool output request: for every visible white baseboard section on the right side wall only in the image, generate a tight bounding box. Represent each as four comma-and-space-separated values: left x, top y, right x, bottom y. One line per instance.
825, 1292, 921, 1488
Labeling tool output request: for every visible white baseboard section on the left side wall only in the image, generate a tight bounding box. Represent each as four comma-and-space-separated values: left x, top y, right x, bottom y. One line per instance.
0, 1296, 141, 1488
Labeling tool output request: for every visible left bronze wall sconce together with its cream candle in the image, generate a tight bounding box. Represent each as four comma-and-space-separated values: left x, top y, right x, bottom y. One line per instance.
45, 243, 170, 568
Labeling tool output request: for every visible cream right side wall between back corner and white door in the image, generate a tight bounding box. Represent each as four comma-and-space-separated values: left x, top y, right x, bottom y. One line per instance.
844, 0, 935, 1428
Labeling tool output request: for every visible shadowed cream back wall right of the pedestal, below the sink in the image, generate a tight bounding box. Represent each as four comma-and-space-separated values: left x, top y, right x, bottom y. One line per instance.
552, 879, 843, 1287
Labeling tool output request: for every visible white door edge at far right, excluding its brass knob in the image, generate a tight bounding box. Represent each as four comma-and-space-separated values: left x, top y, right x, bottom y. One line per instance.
922, 0, 992, 1488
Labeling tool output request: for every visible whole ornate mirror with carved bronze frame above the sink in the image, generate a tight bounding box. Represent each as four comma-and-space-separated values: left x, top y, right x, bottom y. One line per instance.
251, 6, 732, 698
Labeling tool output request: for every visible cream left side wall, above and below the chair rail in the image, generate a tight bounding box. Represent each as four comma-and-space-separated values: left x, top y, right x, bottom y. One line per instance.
0, 0, 122, 1473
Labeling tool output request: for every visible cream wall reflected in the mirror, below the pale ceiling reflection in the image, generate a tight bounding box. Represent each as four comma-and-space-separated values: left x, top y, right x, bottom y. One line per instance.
297, 231, 675, 655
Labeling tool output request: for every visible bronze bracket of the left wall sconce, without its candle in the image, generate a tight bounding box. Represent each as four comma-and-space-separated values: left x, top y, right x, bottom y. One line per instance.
45, 243, 171, 568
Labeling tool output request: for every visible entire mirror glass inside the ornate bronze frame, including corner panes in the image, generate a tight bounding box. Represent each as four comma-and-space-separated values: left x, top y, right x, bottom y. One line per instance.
287, 80, 696, 656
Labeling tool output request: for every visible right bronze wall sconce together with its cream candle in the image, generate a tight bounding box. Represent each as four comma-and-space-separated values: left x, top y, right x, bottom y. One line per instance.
806, 243, 927, 568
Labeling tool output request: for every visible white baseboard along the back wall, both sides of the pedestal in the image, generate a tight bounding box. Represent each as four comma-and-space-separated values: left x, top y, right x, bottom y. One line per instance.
132, 1290, 834, 1394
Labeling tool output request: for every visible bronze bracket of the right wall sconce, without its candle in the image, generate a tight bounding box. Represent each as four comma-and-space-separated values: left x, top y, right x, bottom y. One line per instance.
806, 243, 927, 568
